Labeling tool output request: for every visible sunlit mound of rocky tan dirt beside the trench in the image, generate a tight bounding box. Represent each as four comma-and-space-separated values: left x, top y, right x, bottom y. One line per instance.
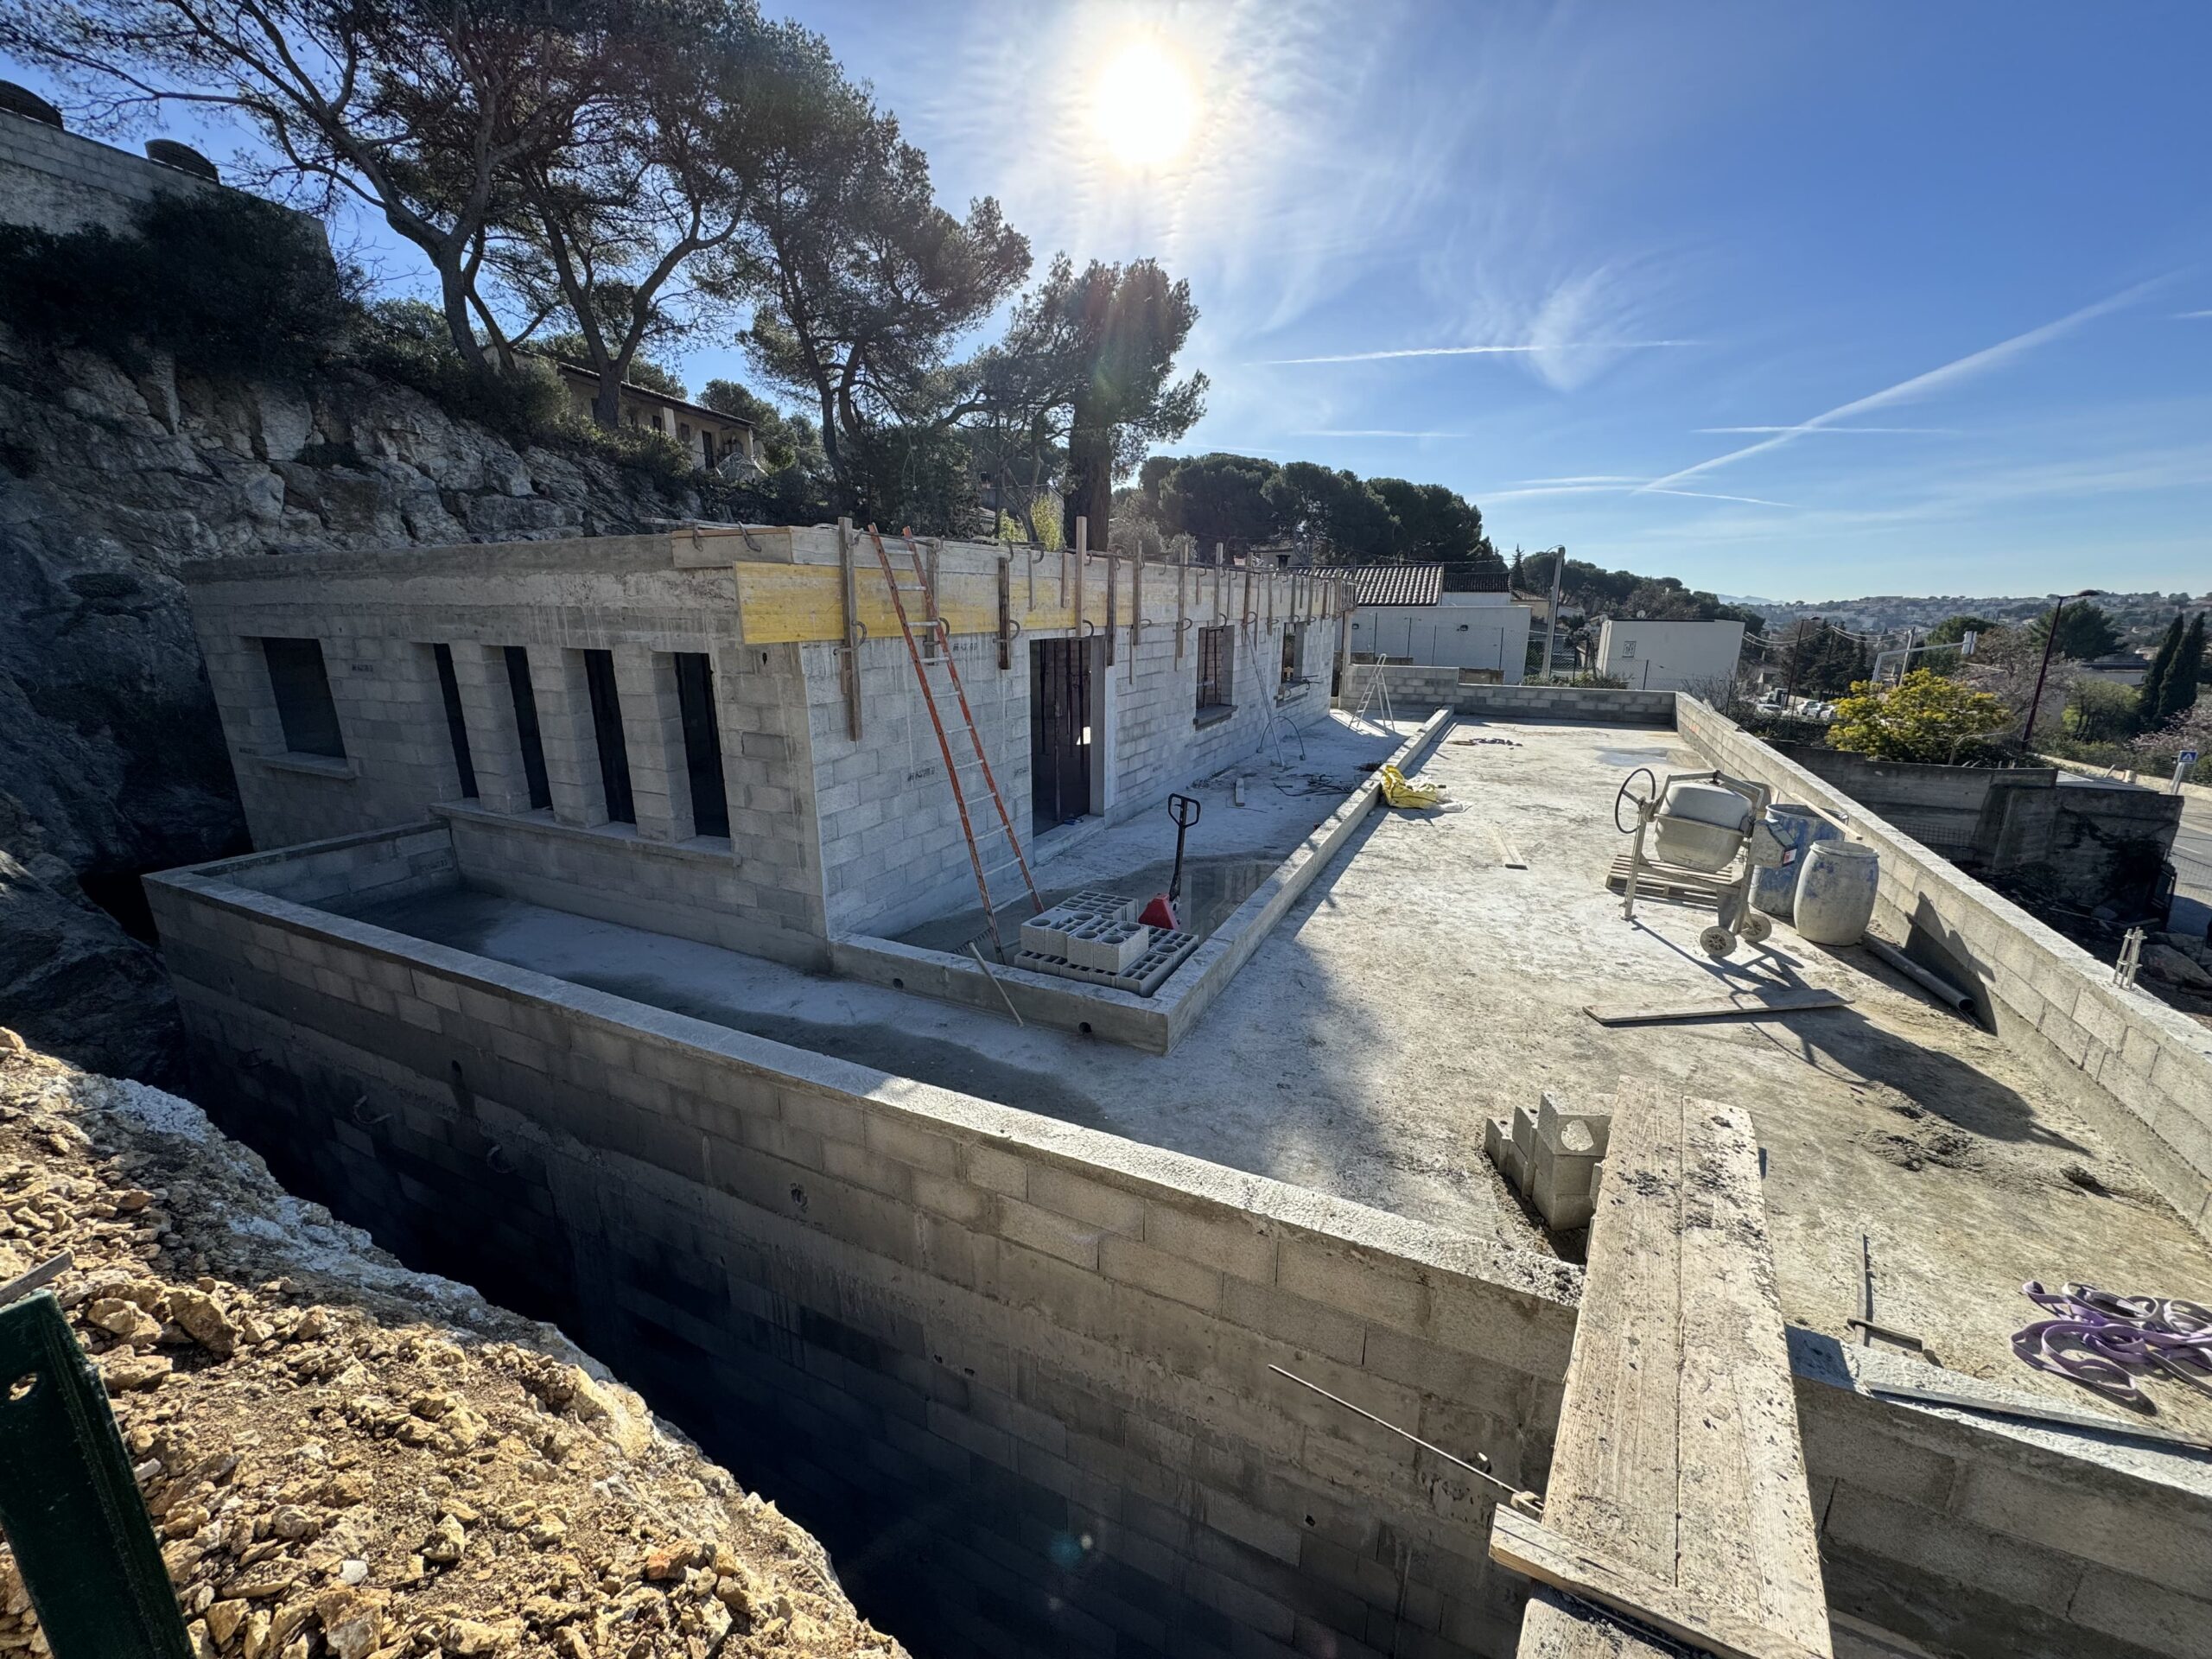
0, 1031, 900, 1659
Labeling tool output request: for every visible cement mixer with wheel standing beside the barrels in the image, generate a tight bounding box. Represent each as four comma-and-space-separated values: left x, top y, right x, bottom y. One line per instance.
1606, 766, 1787, 957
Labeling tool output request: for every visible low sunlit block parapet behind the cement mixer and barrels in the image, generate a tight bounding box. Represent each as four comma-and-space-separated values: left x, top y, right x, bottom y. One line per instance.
1675, 695, 2212, 1239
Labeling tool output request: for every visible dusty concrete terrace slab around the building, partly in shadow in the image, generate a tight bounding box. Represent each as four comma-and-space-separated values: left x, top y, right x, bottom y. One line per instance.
340, 721, 2212, 1429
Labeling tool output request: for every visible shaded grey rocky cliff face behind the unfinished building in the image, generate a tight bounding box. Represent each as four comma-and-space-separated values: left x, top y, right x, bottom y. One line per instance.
0, 327, 725, 1075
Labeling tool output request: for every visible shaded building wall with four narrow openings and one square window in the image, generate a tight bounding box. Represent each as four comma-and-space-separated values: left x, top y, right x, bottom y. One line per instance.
188, 536, 825, 967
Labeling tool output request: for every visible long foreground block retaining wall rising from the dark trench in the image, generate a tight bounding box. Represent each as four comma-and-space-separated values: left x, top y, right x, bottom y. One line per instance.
150, 865, 1580, 1659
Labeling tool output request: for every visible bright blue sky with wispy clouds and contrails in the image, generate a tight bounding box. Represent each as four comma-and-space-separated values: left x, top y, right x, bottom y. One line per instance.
21, 0, 2212, 597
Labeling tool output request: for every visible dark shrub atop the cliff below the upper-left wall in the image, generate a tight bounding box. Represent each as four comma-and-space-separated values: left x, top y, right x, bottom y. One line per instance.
0, 190, 359, 378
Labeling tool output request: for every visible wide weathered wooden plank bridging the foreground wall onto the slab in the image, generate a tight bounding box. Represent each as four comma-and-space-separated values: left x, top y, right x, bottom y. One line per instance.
1493, 1079, 1829, 1659
